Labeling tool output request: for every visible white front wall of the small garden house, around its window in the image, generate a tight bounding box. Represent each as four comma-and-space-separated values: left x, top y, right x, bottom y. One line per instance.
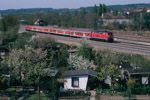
64, 75, 88, 90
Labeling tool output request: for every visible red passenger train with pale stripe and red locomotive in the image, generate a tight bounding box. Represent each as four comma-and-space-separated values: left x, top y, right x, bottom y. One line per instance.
25, 26, 114, 42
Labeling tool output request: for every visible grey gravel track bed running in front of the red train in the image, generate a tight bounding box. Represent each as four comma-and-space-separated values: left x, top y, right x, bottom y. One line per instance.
37, 33, 150, 55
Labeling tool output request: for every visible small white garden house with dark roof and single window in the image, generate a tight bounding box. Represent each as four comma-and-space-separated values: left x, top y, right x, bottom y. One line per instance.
64, 70, 98, 90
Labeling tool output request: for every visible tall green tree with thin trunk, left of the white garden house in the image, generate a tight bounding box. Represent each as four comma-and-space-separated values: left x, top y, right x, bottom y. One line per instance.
22, 47, 47, 93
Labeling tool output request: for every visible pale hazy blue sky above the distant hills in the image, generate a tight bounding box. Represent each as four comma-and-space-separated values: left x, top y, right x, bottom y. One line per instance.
0, 0, 150, 10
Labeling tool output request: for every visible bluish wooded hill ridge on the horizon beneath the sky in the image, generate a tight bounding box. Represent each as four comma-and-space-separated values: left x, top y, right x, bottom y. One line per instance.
0, 3, 150, 14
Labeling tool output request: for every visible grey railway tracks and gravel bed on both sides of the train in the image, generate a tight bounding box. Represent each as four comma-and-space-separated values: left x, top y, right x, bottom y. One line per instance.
19, 26, 150, 55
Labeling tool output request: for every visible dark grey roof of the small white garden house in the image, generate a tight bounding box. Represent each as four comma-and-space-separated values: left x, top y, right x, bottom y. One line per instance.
64, 70, 97, 77
